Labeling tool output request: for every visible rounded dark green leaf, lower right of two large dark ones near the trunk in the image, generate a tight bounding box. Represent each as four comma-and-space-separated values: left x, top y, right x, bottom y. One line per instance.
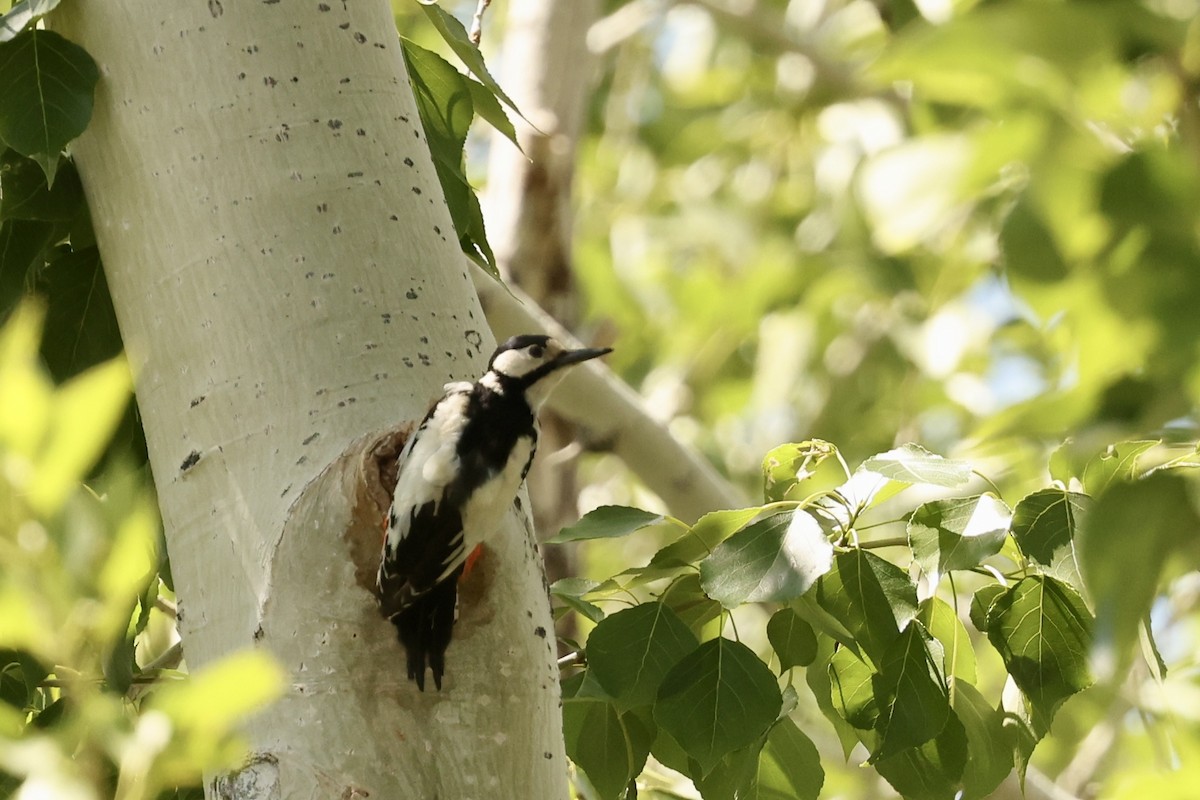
654, 637, 784, 774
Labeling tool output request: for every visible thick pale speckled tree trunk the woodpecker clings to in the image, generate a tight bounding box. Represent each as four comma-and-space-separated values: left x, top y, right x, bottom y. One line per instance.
53, 0, 566, 800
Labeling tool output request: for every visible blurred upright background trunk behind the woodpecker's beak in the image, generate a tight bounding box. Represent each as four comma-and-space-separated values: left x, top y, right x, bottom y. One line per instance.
485, 0, 600, 639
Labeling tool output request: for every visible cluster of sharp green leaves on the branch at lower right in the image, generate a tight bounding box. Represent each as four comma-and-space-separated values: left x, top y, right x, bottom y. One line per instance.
552, 441, 1200, 800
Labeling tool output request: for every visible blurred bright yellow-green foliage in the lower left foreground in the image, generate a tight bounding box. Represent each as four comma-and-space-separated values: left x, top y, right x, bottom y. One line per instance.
0, 302, 281, 800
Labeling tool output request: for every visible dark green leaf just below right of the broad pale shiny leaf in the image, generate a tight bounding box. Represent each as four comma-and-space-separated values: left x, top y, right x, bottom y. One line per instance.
816, 549, 917, 664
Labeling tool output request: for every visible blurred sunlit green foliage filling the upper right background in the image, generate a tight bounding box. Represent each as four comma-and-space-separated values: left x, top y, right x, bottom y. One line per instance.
568, 0, 1200, 487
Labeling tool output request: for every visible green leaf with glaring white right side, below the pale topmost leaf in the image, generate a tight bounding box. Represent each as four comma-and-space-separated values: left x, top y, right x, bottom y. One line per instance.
908, 494, 1012, 589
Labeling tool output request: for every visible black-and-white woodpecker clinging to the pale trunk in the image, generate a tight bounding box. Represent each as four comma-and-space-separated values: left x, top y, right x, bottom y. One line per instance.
377, 335, 612, 692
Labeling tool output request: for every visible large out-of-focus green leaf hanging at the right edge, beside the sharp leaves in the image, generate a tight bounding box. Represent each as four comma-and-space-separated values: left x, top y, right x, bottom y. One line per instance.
1078, 473, 1200, 680
